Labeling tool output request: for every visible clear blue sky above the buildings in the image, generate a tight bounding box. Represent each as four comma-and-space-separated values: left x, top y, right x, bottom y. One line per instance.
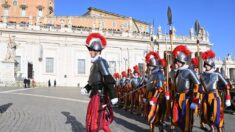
55, 0, 235, 58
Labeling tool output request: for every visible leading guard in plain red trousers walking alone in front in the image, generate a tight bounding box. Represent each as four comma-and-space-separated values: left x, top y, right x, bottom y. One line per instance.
81, 33, 118, 132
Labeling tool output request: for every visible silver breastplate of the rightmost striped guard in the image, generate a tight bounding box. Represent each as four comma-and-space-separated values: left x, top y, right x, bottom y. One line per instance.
201, 73, 219, 92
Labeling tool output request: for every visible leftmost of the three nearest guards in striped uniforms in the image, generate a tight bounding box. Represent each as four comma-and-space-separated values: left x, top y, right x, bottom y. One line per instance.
146, 51, 169, 132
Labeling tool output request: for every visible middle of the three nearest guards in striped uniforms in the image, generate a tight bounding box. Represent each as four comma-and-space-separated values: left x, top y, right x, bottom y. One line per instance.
172, 45, 200, 132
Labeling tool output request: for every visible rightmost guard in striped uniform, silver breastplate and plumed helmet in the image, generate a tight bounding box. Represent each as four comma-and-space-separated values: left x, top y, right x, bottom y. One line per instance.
201, 50, 231, 132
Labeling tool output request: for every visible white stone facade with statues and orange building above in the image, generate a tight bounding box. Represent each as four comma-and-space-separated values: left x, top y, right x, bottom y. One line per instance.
0, 0, 233, 86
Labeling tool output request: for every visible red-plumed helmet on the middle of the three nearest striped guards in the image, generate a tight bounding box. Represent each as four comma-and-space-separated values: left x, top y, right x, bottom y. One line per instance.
173, 45, 191, 63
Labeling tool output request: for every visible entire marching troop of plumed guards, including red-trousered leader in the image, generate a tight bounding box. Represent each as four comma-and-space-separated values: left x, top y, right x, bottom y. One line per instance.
81, 33, 232, 132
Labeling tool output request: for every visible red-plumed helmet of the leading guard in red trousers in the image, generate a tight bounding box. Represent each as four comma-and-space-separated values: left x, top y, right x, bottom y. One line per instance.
86, 33, 107, 51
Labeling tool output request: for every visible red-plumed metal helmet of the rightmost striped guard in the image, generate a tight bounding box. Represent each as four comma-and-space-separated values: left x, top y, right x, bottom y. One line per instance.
202, 50, 215, 67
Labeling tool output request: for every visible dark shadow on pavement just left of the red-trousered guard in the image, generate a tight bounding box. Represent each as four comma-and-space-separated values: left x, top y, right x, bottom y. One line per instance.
61, 111, 85, 132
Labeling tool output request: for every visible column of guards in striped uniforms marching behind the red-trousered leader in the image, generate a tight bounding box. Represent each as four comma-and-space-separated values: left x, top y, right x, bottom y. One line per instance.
113, 45, 232, 132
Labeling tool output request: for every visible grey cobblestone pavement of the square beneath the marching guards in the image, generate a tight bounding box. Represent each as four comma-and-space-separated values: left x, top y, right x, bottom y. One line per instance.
0, 87, 235, 132
